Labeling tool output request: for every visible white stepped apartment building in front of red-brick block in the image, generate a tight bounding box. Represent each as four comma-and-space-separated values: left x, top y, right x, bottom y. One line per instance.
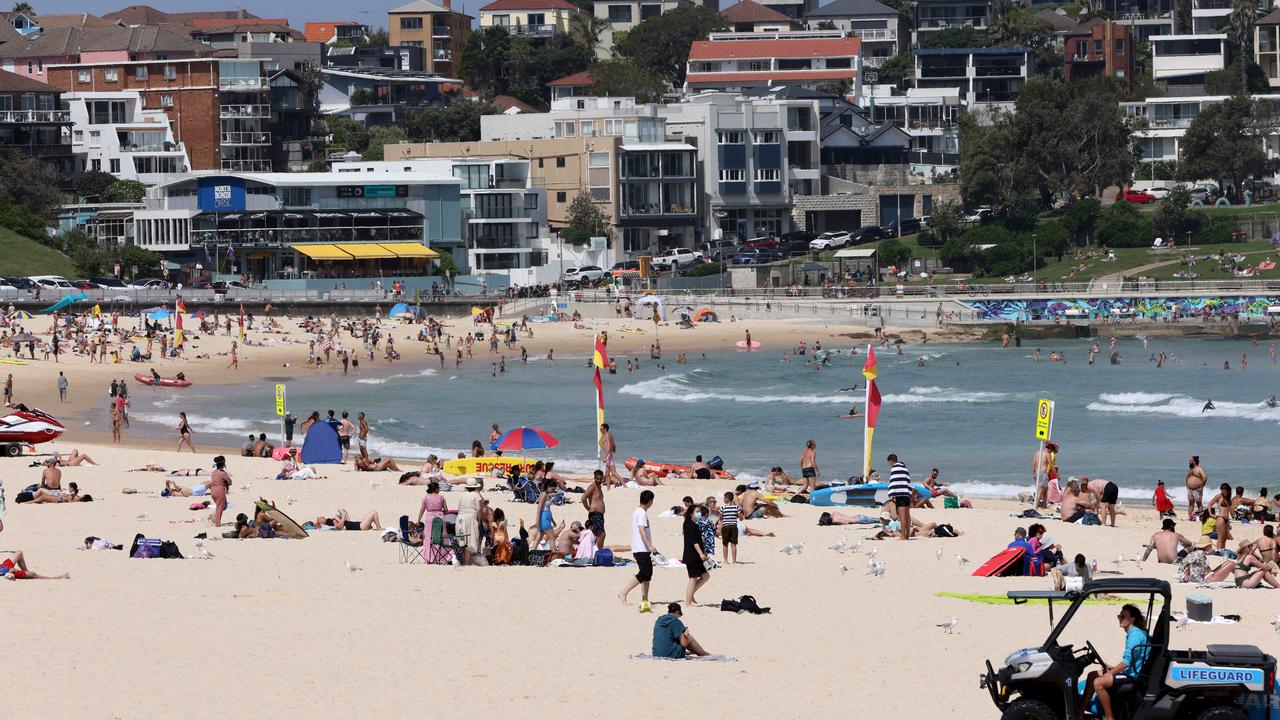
63, 91, 191, 184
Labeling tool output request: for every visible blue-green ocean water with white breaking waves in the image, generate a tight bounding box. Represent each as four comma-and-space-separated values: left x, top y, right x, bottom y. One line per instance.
122, 338, 1280, 500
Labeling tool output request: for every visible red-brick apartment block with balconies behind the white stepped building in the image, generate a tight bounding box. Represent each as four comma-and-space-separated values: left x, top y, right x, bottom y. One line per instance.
46, 58, 271, 172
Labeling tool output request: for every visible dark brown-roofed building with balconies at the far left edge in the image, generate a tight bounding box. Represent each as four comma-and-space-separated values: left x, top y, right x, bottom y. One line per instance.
0, 72, 78, 174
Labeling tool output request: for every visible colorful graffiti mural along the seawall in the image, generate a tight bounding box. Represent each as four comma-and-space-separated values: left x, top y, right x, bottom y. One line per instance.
964, 295, 1280, 322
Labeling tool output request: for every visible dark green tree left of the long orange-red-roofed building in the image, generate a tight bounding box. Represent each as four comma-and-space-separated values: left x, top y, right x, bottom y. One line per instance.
617, 5, 728, 85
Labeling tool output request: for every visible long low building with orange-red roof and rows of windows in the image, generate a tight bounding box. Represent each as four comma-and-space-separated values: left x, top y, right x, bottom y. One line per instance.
685, 31, 861, 94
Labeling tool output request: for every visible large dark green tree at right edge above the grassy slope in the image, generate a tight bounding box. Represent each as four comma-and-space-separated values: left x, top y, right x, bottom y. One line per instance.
1179, 95, 1276, 198
